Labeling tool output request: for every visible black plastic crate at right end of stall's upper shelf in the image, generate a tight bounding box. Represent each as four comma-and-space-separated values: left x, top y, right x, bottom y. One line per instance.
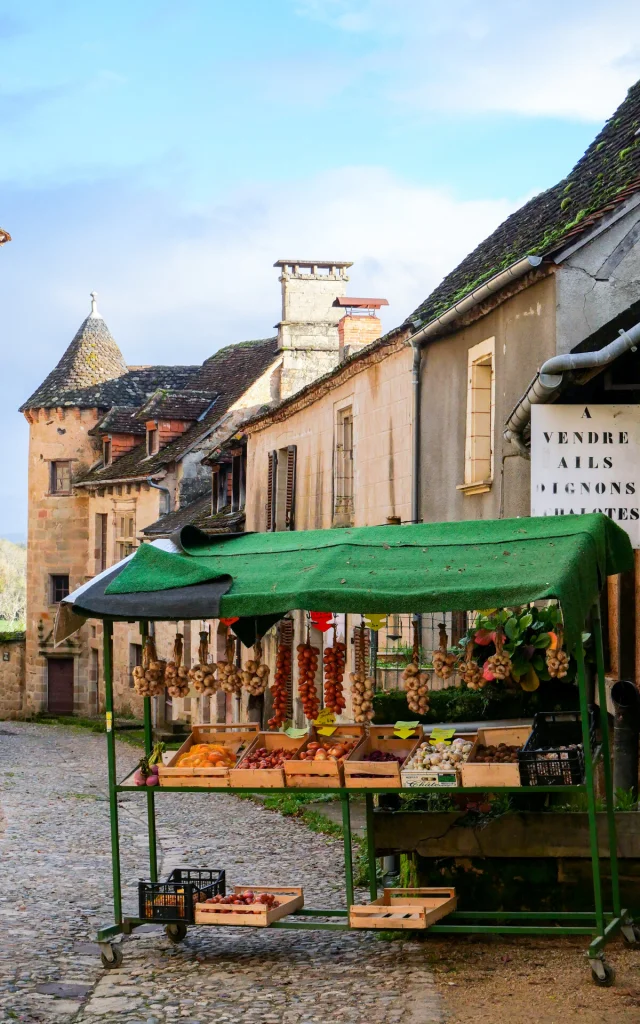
518, 708, 597, 785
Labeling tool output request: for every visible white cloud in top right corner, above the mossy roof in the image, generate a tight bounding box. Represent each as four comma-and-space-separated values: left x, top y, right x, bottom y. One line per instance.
295, 0, 640, 121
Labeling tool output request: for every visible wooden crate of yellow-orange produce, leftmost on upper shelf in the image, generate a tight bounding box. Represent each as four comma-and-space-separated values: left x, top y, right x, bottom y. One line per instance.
158, 723, 258, 790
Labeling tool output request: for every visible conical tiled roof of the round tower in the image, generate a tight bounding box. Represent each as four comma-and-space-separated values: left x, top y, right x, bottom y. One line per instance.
20, 313, 127, 412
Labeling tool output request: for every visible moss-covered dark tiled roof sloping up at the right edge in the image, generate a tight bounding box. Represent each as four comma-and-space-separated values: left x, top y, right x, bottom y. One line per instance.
408, 82, 640, 324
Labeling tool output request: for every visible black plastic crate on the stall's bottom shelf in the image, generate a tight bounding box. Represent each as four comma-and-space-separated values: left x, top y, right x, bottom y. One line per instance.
138, 867, 226, 925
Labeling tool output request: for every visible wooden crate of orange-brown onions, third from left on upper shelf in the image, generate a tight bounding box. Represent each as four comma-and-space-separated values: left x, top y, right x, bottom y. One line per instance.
285, 725, 365, 790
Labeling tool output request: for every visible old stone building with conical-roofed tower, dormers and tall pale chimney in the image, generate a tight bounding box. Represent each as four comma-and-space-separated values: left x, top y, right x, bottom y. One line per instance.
20, 262, 360, 721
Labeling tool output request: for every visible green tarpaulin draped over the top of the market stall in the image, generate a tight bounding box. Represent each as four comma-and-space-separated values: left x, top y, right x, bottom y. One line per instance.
106, 514, 633, 646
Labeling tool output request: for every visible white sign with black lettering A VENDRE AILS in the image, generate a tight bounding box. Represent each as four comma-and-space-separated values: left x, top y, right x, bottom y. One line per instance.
531, 406, 640, 548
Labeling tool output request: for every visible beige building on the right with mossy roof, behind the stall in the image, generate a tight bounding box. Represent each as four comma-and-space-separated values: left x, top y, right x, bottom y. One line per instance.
230, 83, 640, 716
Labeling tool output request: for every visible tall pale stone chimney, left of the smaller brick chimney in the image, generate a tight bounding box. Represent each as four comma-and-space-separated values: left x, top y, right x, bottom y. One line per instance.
273, 259, 352, 398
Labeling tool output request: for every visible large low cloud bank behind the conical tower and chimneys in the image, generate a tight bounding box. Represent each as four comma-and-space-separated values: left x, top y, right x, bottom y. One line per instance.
0, 167, 513, 535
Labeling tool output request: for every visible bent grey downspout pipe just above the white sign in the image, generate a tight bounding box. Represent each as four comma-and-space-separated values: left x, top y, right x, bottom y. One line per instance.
504, 315, 640, 459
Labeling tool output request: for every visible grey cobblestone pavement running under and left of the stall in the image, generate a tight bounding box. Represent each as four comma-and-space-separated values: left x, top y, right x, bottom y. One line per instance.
0, 722, 443, 1024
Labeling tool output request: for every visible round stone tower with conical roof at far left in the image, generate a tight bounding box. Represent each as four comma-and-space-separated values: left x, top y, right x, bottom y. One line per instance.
20, 292, 127, 715
